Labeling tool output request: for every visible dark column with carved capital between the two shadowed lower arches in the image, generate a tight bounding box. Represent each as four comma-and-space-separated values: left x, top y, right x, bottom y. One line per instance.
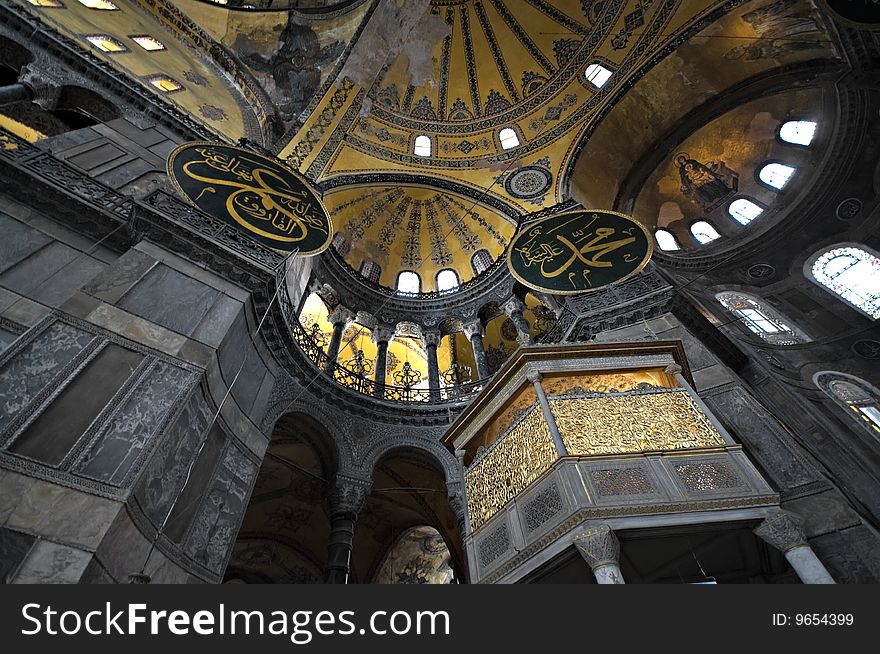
324, 475, 372, 584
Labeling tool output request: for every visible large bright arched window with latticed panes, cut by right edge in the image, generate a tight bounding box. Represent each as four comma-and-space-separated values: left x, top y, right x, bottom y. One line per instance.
804, 245, 880, 320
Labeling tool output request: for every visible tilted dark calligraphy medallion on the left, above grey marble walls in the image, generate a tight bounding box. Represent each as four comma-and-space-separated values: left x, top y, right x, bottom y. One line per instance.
167, 142, 333, 255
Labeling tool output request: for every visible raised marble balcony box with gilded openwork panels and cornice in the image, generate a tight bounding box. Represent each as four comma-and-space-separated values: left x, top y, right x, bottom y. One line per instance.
444, 341, 779, 583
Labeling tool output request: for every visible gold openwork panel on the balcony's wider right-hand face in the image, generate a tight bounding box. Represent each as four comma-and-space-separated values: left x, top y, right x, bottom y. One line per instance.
550, 391, 724, 456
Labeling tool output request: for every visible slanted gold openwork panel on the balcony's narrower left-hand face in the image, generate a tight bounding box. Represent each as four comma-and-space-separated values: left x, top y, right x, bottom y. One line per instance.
465, 407, 557, 530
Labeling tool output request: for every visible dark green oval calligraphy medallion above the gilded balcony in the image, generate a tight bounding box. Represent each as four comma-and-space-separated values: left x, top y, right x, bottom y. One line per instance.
507, 209, 654, 295
